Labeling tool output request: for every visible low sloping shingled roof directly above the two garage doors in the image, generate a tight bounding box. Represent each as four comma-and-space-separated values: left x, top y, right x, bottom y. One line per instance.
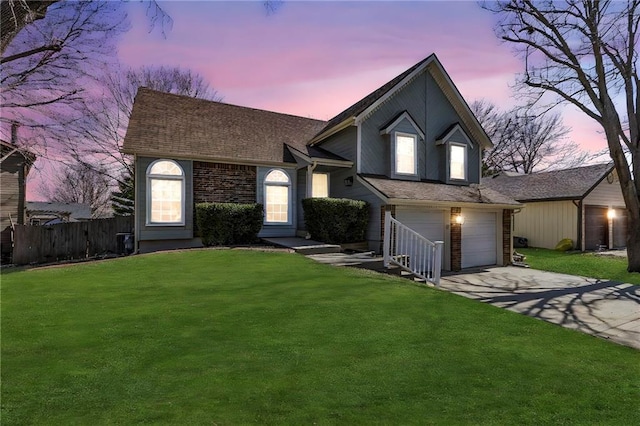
360, 176, 521, 208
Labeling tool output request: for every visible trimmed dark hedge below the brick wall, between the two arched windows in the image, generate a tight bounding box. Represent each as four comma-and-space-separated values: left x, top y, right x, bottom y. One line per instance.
196, 203, 263, 246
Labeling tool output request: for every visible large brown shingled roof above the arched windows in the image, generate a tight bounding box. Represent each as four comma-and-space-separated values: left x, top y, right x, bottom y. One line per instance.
122, 88, 326, 164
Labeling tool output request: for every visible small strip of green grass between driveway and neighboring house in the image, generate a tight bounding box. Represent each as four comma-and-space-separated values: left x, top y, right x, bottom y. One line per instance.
517, 248, 640, 285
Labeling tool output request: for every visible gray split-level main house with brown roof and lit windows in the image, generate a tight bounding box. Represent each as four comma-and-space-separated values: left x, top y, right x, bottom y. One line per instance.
123, 55, 521, 270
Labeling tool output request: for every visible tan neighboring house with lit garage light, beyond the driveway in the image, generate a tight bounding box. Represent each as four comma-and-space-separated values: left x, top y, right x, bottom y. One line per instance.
483, 163, 627, 251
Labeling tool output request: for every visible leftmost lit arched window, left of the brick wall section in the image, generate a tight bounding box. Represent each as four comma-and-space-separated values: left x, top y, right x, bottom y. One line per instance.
147, 160, 185, 225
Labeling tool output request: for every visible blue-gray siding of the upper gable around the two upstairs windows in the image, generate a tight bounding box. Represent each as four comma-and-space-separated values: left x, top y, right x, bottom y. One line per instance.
360, 73, 480, 183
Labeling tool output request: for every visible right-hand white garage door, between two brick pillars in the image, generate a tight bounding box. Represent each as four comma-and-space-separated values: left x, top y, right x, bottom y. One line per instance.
462, 210, 497, 268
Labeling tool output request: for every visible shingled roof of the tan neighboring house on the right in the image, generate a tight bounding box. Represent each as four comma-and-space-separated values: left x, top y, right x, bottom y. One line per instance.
482, 163, 613, 202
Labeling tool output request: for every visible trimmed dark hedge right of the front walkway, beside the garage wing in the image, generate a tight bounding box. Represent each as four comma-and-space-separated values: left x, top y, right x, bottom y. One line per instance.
302, 198, 369, 244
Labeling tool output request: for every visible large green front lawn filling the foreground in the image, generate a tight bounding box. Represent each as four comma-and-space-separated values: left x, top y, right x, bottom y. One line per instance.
1, 250, 640, 425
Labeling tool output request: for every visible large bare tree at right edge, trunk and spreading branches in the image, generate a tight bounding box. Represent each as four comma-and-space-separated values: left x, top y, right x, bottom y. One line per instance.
483, 0, 640, 272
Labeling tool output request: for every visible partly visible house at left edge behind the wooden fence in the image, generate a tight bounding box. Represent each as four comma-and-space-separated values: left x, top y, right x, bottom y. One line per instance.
0, 138, 36, 258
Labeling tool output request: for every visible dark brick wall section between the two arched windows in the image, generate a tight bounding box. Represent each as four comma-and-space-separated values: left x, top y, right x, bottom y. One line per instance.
193, 161, 257, 203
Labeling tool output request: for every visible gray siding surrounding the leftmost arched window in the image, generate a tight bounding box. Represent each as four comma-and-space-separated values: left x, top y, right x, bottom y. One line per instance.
135, 157, 193, 250
